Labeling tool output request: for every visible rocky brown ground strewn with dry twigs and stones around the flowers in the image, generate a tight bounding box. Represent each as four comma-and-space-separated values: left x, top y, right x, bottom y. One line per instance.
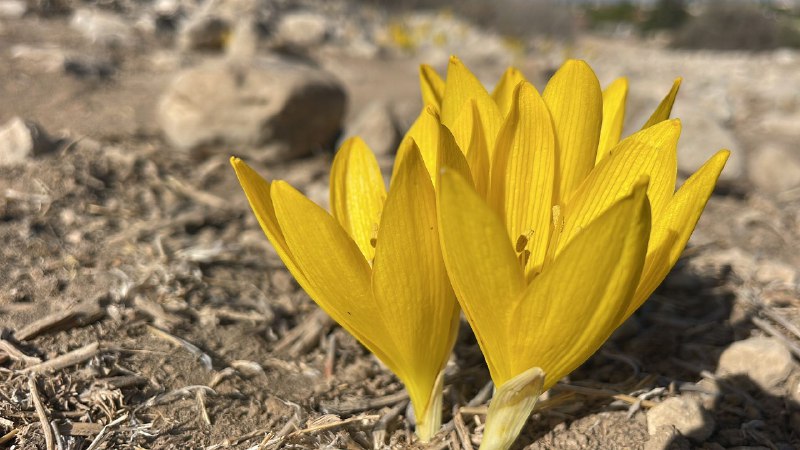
0, 0, 800, 450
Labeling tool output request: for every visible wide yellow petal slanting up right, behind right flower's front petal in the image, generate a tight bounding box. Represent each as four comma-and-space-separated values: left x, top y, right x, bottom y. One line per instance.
558, 120, 681, 253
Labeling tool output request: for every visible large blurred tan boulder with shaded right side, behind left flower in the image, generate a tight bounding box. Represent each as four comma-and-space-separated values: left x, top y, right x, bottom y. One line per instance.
158, 58, 346, 156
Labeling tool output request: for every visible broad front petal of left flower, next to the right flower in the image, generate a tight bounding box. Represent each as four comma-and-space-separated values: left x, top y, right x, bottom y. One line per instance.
372, 147, 459, 440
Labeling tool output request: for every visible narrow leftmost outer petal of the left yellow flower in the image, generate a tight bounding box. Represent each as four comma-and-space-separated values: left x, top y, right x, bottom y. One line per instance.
230, 157, 305, 284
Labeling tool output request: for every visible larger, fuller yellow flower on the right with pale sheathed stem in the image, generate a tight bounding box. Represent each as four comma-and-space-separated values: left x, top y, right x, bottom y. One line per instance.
424, 58, 728, 449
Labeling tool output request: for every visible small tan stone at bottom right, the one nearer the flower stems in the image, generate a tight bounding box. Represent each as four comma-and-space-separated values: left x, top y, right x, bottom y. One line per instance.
647, 397, 715, 442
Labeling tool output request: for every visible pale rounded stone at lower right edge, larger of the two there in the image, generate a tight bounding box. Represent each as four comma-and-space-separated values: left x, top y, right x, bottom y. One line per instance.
717, 336, 794, 392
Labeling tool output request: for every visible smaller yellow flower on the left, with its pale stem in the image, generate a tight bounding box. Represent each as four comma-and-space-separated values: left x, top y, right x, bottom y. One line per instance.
231, 138, 459, 441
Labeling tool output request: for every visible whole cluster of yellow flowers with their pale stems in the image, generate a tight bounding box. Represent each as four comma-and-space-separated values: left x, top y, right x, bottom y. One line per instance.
231, 57, 728, 450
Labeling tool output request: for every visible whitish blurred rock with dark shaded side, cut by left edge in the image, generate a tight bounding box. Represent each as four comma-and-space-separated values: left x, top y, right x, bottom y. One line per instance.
0, 117, 53, 166
